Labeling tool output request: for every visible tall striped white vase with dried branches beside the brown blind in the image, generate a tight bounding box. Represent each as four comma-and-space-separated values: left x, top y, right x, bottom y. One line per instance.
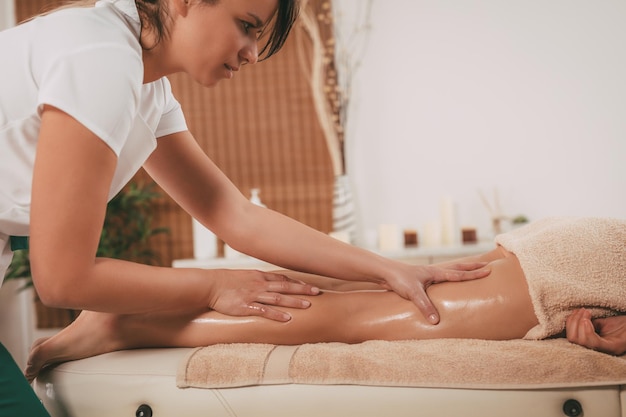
298, 0, 373, 242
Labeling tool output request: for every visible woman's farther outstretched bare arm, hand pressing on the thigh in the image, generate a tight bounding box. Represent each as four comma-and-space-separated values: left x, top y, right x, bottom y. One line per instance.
144, 132, 489, 324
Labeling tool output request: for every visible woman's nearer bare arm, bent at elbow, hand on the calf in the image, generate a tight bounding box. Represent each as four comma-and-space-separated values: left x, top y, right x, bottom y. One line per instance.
30, 106, 316, 321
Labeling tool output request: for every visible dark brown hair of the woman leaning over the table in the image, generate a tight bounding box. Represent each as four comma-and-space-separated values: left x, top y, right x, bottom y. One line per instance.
135, 0, 300, 59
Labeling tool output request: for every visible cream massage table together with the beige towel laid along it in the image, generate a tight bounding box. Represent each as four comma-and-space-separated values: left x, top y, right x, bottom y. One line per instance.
34, 339, 626, 417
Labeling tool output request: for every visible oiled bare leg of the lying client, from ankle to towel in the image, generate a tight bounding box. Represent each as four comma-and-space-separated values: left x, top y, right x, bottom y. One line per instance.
113, 248, 537, 347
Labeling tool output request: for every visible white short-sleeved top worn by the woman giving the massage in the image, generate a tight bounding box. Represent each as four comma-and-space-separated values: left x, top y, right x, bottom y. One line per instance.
0, 0, 187, 280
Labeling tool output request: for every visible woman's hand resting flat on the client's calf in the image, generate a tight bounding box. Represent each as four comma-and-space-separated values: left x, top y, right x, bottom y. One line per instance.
209, 270, 320, 322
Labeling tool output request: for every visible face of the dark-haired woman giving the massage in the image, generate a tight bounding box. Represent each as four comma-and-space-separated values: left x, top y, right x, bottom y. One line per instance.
170, 0, 278, 87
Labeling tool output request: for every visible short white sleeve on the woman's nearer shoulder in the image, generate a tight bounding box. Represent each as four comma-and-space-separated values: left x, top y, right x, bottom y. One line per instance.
38, 44, 143, 155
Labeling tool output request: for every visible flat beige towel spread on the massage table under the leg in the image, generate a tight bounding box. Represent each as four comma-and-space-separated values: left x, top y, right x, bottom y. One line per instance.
177, 339, 626, 389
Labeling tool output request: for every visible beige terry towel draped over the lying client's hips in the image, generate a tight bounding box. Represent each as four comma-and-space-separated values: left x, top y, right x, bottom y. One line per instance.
496, 217, 626, 339
